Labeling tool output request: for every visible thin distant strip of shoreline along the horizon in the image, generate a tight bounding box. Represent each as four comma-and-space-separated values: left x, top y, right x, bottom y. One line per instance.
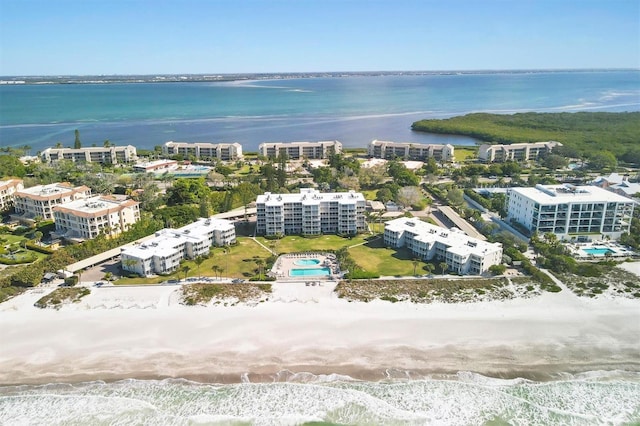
0, 68, 640, 86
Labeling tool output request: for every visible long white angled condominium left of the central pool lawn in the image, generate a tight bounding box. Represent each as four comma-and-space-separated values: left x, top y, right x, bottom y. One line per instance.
120, 218, 236, 276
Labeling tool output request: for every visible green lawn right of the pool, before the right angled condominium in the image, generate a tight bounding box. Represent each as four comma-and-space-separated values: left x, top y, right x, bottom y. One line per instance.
349, 238, 440, 276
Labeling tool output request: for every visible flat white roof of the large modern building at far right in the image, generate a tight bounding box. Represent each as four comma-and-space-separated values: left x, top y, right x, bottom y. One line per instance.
509, 185, 632, 204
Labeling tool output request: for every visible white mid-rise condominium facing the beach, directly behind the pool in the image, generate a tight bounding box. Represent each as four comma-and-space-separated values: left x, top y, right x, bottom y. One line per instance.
256, 188, 367, 235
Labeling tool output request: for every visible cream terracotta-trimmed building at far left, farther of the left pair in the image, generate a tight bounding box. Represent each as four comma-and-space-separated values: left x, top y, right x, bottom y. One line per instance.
13, 182, 91, 220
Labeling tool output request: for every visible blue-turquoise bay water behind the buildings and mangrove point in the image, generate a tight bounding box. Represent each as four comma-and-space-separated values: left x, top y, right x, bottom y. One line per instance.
0, 71, 640, 153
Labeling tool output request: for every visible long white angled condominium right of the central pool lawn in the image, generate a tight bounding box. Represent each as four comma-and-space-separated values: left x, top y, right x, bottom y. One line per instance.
384, 217, 502, 275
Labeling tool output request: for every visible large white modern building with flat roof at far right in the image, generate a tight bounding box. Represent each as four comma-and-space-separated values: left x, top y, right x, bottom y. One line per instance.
507, 184, 634, 241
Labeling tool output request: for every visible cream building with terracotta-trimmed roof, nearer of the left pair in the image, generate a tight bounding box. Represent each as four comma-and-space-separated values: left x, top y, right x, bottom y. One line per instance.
53, 195, 140, 241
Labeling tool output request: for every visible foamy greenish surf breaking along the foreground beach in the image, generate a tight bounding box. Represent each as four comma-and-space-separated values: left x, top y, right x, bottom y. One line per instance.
0, 371, 640, 425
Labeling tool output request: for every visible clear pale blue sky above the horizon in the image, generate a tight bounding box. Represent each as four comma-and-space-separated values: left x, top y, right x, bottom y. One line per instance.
0, 0, 640, 76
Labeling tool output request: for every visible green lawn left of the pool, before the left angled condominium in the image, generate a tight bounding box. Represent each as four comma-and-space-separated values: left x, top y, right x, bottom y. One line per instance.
114, 238, 269, 284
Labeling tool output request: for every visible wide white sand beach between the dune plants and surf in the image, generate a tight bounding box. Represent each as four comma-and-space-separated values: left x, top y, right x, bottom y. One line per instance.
0, 283, 640, 383
